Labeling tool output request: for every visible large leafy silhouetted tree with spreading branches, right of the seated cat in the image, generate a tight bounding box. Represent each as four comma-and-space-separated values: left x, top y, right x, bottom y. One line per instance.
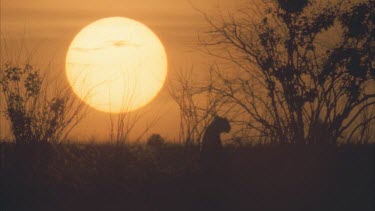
200, 0, 375, 144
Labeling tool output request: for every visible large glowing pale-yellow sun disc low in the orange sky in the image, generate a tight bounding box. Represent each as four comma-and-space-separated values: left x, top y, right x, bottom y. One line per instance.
66, 17, 167, 113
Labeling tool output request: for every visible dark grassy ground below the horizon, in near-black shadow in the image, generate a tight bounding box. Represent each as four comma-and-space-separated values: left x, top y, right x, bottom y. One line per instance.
0, 143, 375, 211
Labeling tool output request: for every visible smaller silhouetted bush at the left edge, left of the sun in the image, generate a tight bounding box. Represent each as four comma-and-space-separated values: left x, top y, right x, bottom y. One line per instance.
0, 62, 87, 143
